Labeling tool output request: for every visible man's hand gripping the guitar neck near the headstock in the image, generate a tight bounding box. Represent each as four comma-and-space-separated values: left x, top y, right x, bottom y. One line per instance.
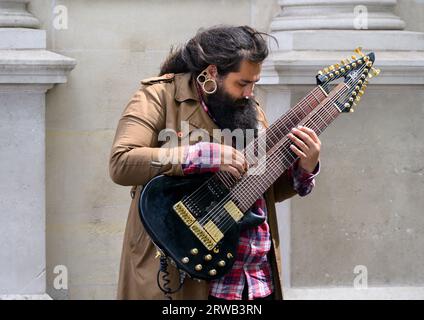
288, 126, 321, 172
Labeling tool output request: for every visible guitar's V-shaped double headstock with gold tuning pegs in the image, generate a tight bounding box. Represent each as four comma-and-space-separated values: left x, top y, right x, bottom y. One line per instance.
316, 47, 380, 112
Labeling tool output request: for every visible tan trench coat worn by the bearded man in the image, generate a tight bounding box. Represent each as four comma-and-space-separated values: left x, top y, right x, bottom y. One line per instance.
109, 74, 296, 300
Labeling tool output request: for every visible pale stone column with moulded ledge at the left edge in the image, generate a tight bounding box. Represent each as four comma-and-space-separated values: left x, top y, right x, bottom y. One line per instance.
0, 0, 76, 299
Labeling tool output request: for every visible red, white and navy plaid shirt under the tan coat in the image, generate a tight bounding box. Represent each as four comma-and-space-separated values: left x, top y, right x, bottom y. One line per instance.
182, 142, 319, 300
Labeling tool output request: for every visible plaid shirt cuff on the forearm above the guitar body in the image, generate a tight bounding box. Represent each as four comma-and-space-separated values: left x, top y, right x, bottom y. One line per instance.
182, 142, 221, 175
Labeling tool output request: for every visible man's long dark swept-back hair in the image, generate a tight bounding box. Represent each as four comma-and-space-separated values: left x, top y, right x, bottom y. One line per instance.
159, 25, 276, 76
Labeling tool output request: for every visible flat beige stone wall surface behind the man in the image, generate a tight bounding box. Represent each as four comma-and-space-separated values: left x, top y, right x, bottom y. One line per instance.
15, 0, 424, 299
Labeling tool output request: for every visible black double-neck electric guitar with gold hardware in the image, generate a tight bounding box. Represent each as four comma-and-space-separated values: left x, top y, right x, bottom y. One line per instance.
139, 48, 379, 280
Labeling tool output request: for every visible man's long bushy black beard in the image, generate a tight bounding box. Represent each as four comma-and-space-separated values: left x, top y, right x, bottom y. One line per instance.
206, 88, 258, 142
